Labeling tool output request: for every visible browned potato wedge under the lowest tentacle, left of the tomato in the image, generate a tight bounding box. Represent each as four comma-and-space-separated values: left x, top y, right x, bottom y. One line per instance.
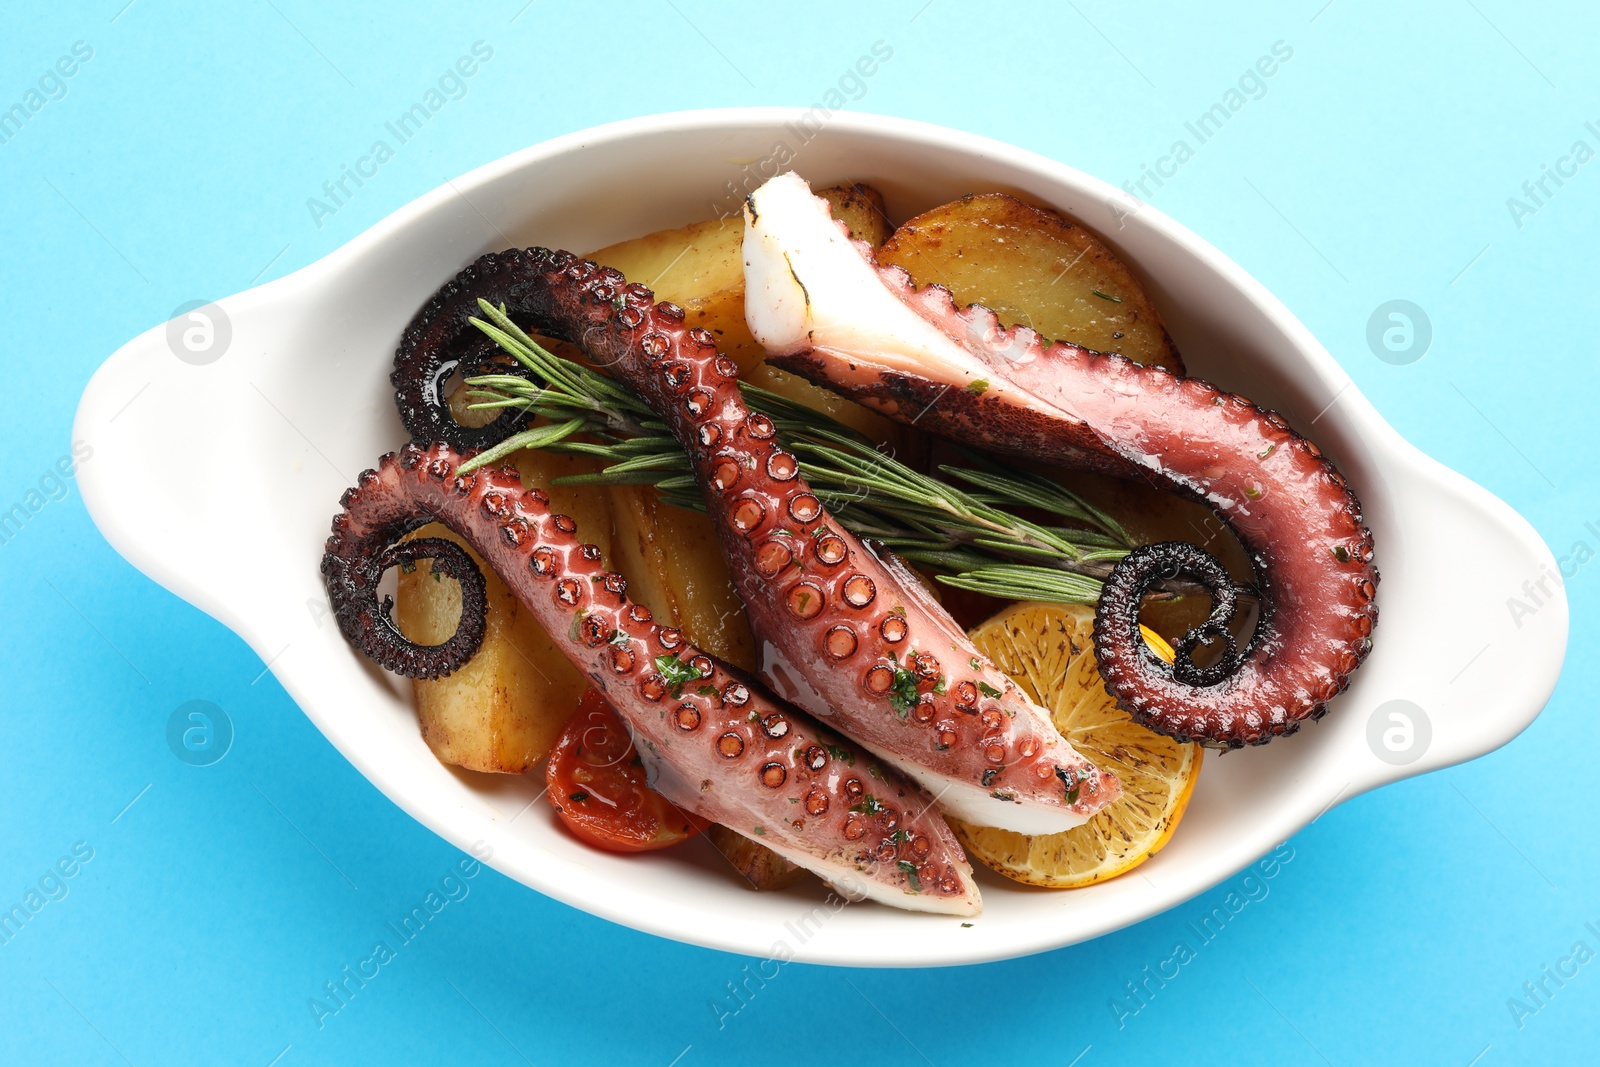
395, 451, 611, 774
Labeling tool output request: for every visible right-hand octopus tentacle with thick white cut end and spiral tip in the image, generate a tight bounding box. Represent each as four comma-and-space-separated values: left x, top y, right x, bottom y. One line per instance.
746, 176, 1378, 747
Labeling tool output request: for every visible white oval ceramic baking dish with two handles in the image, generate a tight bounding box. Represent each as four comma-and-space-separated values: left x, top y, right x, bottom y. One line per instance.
74, 109, 1566, 966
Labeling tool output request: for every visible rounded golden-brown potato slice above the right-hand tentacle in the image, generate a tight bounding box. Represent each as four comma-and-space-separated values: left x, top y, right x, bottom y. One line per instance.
878, 192, 1182, 373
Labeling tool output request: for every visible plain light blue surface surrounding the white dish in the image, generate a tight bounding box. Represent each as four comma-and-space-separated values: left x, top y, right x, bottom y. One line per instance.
0, 0, 1600, 1067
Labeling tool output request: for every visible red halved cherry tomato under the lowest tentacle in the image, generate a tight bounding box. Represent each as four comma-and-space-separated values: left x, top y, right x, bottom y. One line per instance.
544, 689, 710, 853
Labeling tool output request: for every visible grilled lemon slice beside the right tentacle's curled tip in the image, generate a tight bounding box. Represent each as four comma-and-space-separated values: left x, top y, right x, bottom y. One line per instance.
950, 601, 1200, 889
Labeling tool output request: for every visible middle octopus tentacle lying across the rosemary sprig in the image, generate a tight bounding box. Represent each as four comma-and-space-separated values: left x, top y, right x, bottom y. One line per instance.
384, 248, 1120, 833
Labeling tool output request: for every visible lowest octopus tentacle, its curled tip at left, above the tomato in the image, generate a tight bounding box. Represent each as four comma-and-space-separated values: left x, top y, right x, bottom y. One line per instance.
322, 443, 979, 915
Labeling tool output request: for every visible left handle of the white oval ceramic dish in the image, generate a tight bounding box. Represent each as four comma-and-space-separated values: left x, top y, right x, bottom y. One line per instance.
72, 279, 318, 629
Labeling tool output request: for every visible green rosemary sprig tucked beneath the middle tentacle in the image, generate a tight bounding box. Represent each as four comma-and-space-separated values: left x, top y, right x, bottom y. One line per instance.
461, 301, 1133, 605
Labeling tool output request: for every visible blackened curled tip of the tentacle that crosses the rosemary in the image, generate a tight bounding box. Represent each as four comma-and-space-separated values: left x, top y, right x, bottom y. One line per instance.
389, 256, 540, 450
